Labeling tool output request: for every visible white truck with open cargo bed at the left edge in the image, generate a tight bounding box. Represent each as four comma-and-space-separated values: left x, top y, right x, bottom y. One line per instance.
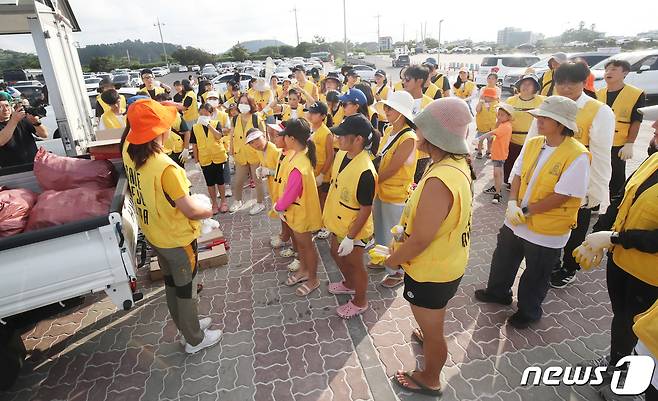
0, 0, 142, 390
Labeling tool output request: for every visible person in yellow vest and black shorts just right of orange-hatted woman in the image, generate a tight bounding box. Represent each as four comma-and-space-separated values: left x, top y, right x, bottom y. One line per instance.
190, 103, 228, 213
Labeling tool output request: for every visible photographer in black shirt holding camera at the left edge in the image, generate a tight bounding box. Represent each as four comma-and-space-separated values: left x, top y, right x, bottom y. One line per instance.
0, 92, 48, 167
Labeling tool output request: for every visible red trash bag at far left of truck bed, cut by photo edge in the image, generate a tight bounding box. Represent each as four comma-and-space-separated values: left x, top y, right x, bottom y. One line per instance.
0, 187, 38, 238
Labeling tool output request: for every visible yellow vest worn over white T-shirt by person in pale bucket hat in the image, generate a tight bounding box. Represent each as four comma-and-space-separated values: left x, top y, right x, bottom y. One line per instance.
518, 136, 591, 235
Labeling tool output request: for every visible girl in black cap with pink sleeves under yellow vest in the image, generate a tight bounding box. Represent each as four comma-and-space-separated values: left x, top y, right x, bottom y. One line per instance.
272, 119, 322, 297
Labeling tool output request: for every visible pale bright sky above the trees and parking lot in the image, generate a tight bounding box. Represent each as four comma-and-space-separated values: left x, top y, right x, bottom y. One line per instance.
0, 0, 658, 53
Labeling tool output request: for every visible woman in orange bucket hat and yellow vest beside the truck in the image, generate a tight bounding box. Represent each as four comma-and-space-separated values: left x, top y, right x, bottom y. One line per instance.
121, 98, 222, 354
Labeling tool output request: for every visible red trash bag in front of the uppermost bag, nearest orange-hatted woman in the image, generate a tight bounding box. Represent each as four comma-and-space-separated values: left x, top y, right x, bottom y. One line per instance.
25, 188, 114, 231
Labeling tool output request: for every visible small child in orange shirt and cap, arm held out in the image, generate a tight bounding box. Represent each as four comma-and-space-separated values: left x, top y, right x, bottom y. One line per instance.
475, 103, 514, 204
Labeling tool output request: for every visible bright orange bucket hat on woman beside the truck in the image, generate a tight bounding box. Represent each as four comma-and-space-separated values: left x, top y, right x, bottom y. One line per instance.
126, 99, 178, 145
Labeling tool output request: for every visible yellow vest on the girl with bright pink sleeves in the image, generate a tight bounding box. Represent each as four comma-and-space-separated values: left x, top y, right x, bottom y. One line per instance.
278, 152, 322, 233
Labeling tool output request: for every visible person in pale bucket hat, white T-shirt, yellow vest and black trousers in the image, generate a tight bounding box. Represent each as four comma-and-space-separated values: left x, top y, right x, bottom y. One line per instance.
475, 96, 590, 329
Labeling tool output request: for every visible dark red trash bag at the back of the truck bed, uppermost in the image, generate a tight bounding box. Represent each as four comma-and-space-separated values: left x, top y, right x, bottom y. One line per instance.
34, 148, 118, 191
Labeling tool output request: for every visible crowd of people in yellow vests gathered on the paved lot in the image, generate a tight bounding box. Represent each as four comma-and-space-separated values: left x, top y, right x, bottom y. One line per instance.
105, 54, 658, 399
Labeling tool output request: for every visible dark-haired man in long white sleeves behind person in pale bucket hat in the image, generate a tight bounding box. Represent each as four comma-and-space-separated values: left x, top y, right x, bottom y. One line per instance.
526, 63, 615, 288
